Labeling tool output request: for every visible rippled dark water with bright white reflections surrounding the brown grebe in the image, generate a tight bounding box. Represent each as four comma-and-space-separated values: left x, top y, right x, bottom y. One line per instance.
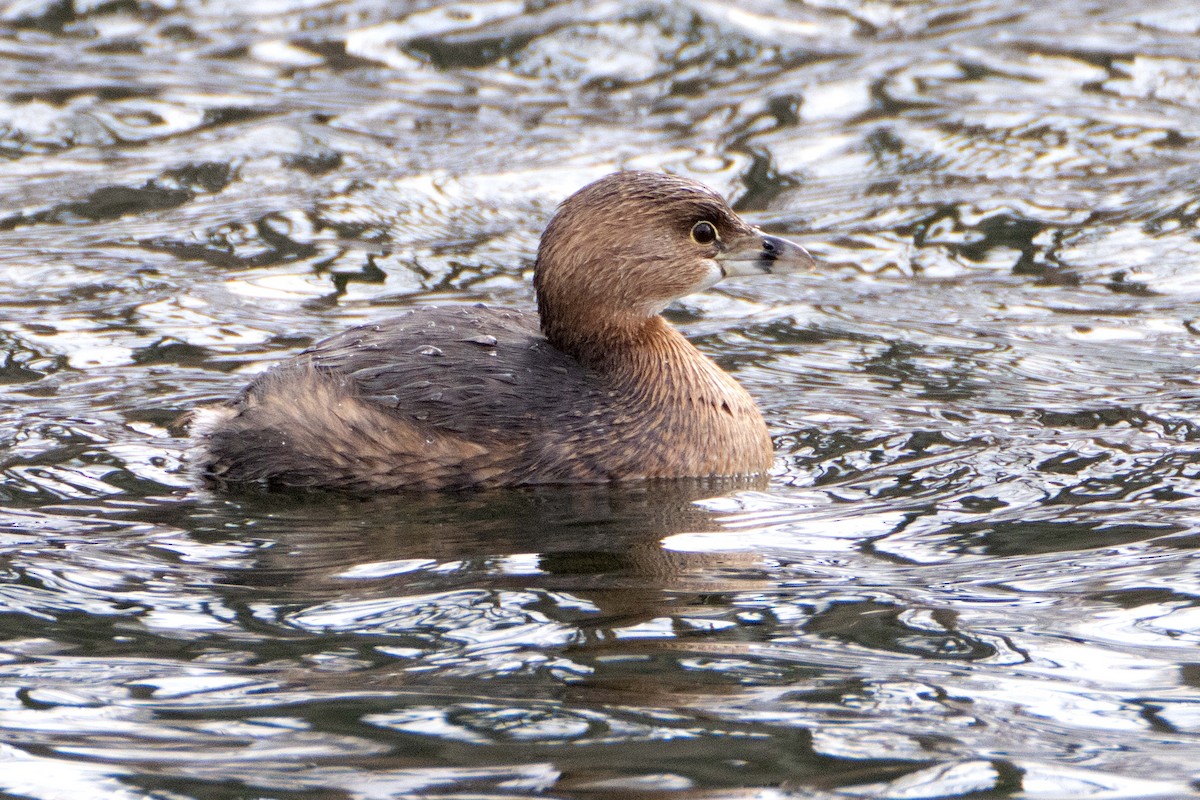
0, 0, 1200, 800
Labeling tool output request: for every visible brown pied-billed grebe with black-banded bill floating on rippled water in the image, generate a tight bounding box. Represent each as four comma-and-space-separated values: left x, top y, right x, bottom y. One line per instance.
199, 172, 812, 491
